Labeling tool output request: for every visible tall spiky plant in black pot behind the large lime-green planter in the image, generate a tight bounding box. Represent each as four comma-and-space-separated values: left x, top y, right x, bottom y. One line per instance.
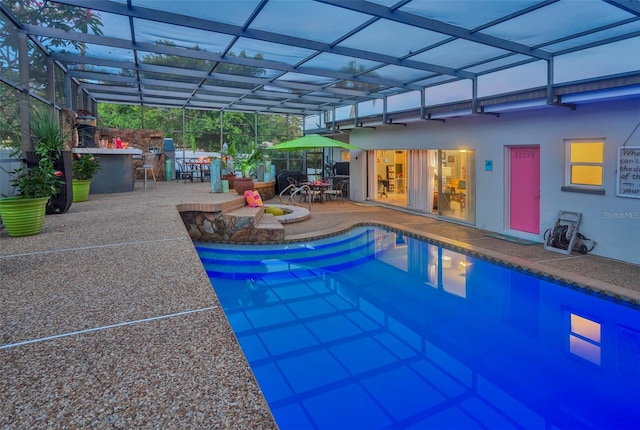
24, 109, 73, 214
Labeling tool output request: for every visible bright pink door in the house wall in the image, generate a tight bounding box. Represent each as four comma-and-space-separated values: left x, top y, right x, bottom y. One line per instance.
509, 146, 540, 234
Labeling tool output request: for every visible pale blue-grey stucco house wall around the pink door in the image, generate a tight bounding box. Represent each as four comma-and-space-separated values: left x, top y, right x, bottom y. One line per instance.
350, 98, 640, 264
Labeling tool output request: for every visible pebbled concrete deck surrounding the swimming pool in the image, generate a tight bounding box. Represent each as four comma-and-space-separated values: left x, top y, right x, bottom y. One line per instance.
0, 182, 640, 429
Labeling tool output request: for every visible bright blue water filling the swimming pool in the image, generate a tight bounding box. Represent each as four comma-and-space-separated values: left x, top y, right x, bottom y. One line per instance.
196, 227, 640, 430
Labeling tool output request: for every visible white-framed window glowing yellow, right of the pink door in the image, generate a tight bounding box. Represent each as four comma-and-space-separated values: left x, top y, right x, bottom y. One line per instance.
565, 139, 604, 190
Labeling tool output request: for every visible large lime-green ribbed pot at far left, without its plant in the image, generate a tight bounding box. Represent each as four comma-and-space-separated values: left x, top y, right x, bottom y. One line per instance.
0, 197, 49, 237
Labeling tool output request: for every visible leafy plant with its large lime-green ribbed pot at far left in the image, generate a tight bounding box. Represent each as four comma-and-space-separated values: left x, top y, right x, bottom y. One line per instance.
0, 157, 62, 237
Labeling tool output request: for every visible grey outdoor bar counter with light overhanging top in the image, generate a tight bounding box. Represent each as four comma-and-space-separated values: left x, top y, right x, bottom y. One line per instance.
73, 148, 142, 194
